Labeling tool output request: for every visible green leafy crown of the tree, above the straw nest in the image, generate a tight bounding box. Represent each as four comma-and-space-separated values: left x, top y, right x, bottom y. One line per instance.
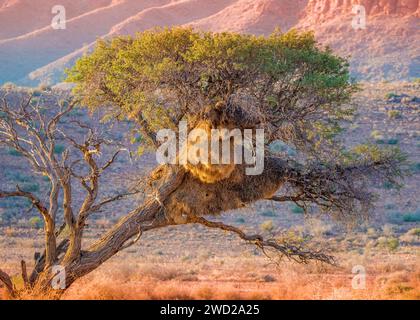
66, 27, 358, 148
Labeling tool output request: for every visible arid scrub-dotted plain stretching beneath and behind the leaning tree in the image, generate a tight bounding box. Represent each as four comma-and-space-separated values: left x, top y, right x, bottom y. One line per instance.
0, 82, 420, 299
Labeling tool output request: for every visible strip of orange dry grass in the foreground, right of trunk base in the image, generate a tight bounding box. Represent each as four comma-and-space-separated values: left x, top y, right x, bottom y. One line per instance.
54, 263, 420, 300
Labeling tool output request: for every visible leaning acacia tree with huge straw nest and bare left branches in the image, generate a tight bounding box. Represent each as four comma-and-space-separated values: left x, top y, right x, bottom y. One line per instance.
0, 28, 404, 295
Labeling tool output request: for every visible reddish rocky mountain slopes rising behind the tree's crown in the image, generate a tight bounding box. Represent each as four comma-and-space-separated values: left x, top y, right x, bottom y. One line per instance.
0, 0, 420, 85
